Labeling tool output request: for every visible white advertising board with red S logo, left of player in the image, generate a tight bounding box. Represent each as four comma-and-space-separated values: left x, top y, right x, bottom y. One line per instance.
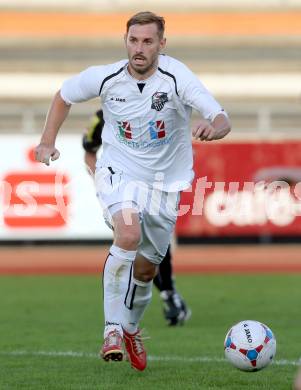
0, 135, 112, 240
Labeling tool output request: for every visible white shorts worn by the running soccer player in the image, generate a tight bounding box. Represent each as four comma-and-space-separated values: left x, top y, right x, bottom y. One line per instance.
95, 167, 180, 264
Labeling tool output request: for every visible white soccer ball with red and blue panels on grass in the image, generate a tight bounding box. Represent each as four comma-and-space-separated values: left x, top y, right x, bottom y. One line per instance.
224, 320, 276, 371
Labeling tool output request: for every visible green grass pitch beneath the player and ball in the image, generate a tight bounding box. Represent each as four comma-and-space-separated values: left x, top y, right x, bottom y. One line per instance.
0, 274, 301, 390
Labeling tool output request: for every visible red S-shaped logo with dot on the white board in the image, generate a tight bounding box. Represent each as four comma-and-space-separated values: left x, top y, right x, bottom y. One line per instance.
3, 149, 70, 229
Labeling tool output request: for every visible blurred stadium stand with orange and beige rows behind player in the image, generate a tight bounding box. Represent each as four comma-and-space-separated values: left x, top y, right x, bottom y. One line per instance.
0, 0, 301, 138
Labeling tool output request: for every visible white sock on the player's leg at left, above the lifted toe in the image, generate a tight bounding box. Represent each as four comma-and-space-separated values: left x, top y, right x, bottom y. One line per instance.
103, 245, 136, 337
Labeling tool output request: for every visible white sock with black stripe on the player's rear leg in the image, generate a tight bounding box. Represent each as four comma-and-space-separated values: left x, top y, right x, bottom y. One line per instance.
121, 274, 153, 333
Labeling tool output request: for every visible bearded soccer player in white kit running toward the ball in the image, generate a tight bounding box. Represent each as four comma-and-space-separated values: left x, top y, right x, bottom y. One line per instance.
35, 12, 230, 371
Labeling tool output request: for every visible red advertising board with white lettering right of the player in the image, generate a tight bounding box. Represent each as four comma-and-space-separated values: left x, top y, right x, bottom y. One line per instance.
177, 142, 301, 237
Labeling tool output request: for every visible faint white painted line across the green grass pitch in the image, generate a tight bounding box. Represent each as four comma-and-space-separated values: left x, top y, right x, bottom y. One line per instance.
0, 350, 301, 366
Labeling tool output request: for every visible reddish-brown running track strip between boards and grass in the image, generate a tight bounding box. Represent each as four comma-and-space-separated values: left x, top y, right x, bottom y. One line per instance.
0, 245, 301, 274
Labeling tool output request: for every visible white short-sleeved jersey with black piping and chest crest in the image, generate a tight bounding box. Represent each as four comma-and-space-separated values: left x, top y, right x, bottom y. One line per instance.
61, 55, 224, 192
